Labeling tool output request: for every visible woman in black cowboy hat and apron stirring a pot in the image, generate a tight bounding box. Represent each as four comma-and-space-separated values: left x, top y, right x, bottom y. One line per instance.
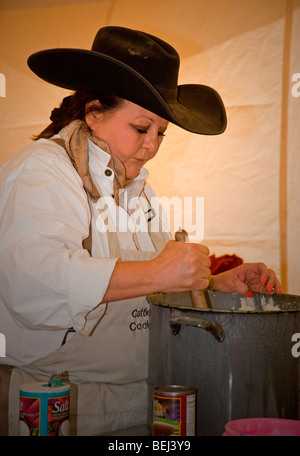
0, 27, 281, 435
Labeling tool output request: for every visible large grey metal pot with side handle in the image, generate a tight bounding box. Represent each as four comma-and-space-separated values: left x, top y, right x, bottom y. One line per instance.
147, 292, 300, 435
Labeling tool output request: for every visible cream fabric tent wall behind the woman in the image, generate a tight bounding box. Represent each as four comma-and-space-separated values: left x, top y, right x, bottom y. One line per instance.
0, 0, 300, 294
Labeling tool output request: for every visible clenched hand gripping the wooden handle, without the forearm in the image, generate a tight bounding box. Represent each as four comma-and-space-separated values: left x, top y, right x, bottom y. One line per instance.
151, 241, 211, 292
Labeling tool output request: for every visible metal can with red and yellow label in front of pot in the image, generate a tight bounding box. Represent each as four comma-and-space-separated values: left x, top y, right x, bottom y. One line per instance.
152, 385, 196, 436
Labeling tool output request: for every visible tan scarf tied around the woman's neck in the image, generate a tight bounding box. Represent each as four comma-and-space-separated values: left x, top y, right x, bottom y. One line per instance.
65, 120, 133, 204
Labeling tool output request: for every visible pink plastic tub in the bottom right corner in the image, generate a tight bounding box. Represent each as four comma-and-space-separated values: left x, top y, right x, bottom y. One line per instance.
223, 418, 300, 436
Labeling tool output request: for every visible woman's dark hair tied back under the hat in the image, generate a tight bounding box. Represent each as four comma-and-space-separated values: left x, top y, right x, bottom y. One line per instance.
33, 89, 124, 140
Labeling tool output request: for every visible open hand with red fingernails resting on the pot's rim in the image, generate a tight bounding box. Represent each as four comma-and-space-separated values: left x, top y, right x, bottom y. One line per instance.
210, 263, 282, 297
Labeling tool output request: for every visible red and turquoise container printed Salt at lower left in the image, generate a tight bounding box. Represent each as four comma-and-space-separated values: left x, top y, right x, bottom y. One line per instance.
19, 388, 70, 436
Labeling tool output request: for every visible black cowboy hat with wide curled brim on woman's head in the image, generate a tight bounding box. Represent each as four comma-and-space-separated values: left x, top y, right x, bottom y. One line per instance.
28, 26, 227, 135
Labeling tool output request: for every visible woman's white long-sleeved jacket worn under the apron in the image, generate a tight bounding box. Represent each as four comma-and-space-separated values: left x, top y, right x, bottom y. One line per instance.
0, 130, 169, 366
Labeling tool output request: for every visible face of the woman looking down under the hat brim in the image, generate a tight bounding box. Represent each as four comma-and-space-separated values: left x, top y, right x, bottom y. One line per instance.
86, 100, 168, 178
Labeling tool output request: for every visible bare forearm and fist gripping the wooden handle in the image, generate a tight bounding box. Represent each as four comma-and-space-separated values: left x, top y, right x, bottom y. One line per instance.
102, 241, 211, 302
